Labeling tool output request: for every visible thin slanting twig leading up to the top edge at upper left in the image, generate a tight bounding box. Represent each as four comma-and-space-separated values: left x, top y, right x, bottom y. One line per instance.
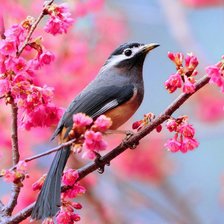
17, 0, 54, 57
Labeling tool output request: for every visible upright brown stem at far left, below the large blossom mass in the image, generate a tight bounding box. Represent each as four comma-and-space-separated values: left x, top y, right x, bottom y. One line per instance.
3, 102, 21, 216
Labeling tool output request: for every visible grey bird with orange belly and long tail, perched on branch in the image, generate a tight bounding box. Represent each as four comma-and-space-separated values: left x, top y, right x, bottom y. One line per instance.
31, 42, 159, 220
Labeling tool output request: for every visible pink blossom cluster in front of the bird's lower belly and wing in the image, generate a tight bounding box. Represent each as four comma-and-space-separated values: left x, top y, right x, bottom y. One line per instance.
69, 113, 112, 159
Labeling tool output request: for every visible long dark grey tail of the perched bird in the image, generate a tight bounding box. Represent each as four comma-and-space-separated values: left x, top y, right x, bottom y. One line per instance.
31, 146, 70, 220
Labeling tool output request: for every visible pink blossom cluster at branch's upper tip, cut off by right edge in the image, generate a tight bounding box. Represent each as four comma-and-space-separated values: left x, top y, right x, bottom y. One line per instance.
205, 56, 224, 93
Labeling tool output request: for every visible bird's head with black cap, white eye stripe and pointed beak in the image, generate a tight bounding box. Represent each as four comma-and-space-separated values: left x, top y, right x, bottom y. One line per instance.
104, 42, 159, 68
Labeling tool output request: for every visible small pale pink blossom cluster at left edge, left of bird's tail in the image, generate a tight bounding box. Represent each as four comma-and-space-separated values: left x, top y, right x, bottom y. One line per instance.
0, 161, 28, 186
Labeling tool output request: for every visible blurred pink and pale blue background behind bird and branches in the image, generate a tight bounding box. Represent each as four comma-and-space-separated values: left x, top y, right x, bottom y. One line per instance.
0, 0, 224, 224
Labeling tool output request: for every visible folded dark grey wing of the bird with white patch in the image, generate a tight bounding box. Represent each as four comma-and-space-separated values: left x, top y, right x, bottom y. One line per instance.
51, 84, 134, 140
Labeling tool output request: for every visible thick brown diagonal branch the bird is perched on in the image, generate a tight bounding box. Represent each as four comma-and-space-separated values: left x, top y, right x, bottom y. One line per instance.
5, 76, 209, 224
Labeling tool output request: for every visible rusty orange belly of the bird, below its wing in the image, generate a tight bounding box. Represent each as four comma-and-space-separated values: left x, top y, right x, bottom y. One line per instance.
105, 95, 141, 129
